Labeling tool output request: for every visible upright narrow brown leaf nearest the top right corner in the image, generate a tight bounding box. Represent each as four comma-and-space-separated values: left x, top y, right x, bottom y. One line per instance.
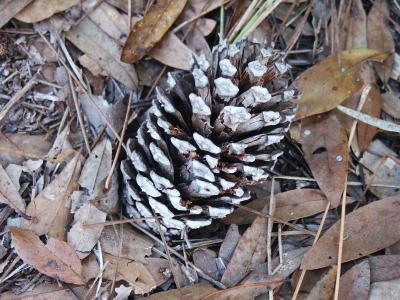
367, 1, 395, 82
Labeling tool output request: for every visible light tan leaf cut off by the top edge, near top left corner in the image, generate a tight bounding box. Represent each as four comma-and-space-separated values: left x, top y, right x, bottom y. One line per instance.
15, 0, 80, 23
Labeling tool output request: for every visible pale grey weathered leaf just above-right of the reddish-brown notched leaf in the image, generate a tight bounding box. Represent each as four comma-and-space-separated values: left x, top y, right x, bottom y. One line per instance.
67, 203, 107, 259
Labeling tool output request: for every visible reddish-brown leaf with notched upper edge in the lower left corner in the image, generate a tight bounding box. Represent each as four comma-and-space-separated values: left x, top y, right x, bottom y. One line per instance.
8, 227, 86, 285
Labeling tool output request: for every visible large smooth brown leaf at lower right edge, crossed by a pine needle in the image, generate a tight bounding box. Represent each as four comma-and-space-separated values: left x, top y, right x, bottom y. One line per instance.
301, 195, 400, 270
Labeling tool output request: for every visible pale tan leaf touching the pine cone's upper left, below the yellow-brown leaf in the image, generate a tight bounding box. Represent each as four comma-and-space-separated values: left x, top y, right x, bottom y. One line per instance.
149, 32, 193, 70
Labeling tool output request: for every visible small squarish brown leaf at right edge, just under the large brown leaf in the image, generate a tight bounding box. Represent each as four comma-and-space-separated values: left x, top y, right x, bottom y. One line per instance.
369, 255, 400, 282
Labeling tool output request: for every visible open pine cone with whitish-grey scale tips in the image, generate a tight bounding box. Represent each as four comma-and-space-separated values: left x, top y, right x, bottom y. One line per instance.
121, 40, 297, 235
